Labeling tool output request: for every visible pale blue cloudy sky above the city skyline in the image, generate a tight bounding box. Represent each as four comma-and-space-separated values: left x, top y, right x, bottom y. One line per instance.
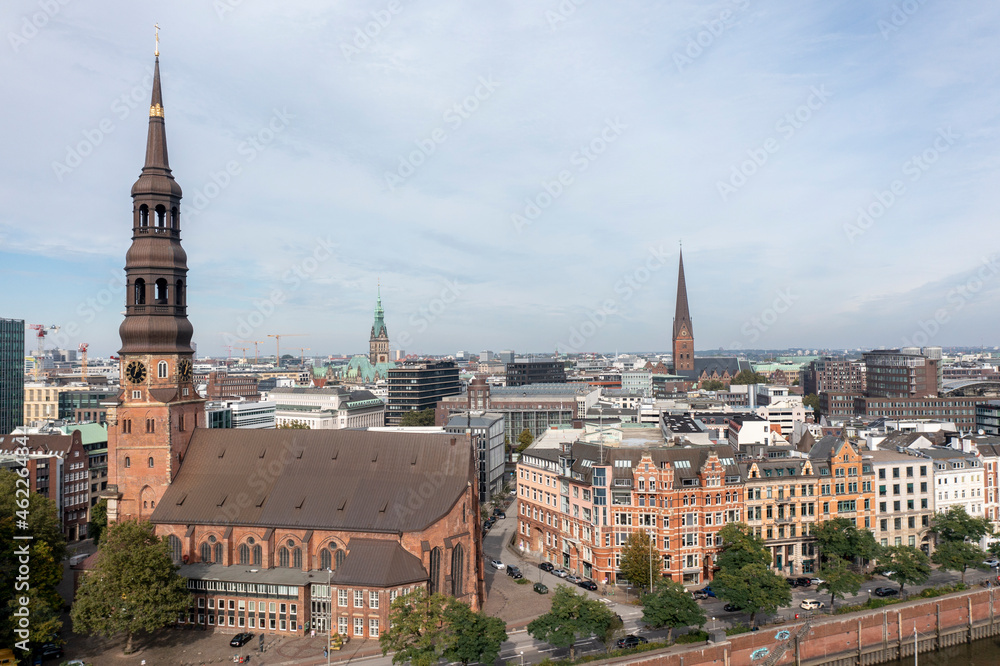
0, 0, 1000, 356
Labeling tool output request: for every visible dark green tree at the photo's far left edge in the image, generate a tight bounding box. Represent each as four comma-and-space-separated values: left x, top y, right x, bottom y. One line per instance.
0, 468, 66, 647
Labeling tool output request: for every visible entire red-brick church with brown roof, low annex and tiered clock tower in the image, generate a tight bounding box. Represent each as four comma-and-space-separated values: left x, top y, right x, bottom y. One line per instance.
98, 54, 485, 639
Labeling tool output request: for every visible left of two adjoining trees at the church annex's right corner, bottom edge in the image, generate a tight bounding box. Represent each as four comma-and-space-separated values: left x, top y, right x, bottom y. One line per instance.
378, 587, 451, 666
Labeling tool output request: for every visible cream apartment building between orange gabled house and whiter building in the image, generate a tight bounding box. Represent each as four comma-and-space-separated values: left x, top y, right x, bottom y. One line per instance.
865, 451, 935, 555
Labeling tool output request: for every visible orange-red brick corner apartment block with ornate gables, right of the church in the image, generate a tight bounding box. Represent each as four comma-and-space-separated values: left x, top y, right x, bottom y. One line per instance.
516, 442, 744, 584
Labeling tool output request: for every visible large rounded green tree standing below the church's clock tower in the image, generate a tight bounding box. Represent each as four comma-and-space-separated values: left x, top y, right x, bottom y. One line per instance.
70, 520, 191, 654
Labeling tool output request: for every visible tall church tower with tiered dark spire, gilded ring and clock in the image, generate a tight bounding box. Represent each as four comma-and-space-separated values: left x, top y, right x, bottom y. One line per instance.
105, 48, 205, 521
